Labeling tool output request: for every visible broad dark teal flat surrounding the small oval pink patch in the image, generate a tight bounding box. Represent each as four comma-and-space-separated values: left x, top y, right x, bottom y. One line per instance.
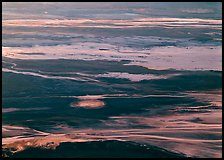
2, 57, 222, 127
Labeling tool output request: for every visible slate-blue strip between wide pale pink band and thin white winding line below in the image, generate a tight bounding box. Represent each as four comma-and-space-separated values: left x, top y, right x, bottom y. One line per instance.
3, 57, 150, 74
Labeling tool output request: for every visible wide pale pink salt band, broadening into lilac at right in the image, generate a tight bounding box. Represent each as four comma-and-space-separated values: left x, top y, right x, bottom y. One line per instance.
2, 43, 222, 71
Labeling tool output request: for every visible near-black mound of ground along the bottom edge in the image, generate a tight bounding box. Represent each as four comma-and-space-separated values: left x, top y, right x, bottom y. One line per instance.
3, 140, 185, 158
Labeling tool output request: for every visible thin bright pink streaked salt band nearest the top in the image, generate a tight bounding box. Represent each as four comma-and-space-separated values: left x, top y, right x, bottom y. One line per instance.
3, 18, 222, 28
